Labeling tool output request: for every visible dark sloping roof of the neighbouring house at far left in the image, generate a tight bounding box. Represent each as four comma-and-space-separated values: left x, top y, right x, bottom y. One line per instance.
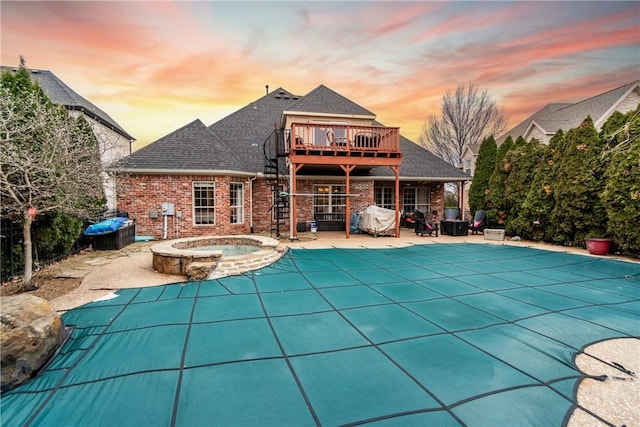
0, 66, 135, 141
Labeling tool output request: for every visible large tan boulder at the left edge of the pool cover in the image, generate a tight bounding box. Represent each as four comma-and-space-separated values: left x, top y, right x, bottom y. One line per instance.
0, 294, 66, 391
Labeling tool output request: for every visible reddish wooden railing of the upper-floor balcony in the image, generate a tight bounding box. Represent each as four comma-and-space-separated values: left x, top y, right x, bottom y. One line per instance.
286, 123, 400, 154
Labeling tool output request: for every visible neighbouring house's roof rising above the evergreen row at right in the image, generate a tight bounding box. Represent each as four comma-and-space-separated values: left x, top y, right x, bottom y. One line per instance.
498, 80, 640, 145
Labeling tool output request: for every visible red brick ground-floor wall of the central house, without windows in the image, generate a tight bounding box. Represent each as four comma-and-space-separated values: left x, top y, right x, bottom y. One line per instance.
117, 175, 444, 239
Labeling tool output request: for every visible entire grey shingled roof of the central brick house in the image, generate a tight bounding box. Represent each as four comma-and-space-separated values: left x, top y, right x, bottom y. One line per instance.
119, 85, 470, 181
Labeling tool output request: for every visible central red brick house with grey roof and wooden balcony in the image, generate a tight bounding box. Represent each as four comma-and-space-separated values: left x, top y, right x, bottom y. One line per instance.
117, 85, 469, 238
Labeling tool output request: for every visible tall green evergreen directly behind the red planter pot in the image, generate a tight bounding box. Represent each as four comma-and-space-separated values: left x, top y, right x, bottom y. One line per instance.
549, 117, 607, 246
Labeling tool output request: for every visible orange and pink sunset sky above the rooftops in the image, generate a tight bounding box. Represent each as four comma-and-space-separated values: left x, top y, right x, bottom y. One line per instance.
0, 0, 640, 149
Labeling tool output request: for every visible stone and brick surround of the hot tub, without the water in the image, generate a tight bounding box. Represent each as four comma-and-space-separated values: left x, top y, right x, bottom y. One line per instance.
151, 235, 284, 280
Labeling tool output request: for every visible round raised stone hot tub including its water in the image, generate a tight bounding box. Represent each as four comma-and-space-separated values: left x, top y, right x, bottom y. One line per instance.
151, 235, 279, 277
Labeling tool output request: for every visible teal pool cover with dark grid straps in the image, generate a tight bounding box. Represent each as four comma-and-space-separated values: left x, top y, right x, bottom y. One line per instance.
1, 244, 640, 427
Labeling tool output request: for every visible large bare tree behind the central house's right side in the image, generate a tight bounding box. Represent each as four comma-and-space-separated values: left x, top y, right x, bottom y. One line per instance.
418, 83, 507, 167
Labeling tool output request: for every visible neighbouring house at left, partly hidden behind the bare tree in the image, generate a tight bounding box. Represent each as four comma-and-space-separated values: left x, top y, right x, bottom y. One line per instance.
0, 66, 135, 211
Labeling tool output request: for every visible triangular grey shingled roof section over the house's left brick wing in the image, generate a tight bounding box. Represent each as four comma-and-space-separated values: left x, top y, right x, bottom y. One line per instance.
115, 119, 248, 174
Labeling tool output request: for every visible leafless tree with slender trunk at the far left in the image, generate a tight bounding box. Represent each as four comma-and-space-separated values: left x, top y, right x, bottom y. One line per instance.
0, 70, 104, 285
